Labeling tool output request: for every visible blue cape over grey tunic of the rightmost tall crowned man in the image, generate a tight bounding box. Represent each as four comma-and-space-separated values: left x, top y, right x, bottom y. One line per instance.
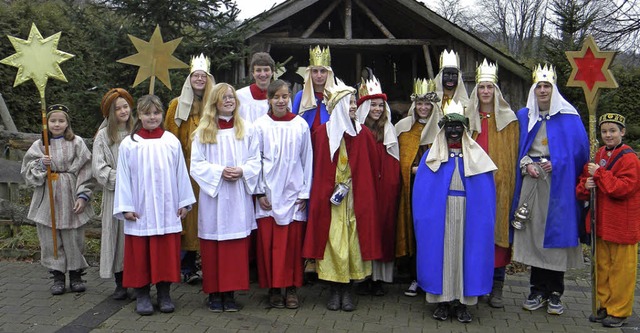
510, 108, 589, 248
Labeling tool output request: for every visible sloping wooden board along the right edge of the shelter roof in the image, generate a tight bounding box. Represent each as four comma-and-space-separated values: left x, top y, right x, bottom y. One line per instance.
398, 0, 531, 80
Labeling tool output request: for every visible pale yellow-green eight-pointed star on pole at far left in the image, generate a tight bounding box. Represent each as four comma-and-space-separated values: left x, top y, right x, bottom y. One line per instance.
0, 24, 74, 99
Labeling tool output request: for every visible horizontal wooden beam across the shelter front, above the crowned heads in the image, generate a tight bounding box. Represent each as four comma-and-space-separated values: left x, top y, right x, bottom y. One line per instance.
252, 37, 446, 47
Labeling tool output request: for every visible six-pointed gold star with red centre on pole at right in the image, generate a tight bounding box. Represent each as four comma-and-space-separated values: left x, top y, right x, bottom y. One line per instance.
565, 35, 618, 104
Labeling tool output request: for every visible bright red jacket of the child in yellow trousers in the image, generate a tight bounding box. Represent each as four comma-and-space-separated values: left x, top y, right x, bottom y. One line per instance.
576, 145, 640, 244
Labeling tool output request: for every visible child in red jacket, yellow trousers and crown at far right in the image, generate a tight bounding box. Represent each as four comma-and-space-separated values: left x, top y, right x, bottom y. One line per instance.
576, 113, 640, 327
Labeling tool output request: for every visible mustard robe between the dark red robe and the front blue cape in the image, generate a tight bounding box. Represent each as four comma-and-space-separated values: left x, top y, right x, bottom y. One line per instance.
396, 121, 426, 257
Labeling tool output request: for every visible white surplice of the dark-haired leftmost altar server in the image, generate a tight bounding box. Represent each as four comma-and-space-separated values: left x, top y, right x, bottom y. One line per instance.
113, 131, 196, 236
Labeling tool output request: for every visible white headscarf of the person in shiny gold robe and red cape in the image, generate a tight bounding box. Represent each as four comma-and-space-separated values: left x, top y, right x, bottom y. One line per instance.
326, 91, 362, 161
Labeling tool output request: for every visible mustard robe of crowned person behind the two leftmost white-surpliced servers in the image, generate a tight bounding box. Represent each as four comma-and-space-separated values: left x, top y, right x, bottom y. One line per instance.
164, 98, 200, 251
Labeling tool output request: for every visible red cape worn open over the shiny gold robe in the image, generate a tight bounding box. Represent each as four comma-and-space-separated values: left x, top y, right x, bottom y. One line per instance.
302, 124, 382, 261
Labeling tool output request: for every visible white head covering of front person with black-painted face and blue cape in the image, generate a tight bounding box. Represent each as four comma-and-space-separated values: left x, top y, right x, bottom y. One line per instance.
425, 115, 498, 177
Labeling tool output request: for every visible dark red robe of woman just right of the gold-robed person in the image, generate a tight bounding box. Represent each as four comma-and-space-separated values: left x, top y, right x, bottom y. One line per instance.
370, 142, 400, 262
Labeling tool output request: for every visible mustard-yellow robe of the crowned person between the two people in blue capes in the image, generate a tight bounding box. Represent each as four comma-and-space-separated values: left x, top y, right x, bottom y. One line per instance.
473, 114, 520, 248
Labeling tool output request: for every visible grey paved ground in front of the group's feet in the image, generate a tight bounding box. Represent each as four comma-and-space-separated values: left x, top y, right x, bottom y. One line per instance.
0, 261, 640, 333
